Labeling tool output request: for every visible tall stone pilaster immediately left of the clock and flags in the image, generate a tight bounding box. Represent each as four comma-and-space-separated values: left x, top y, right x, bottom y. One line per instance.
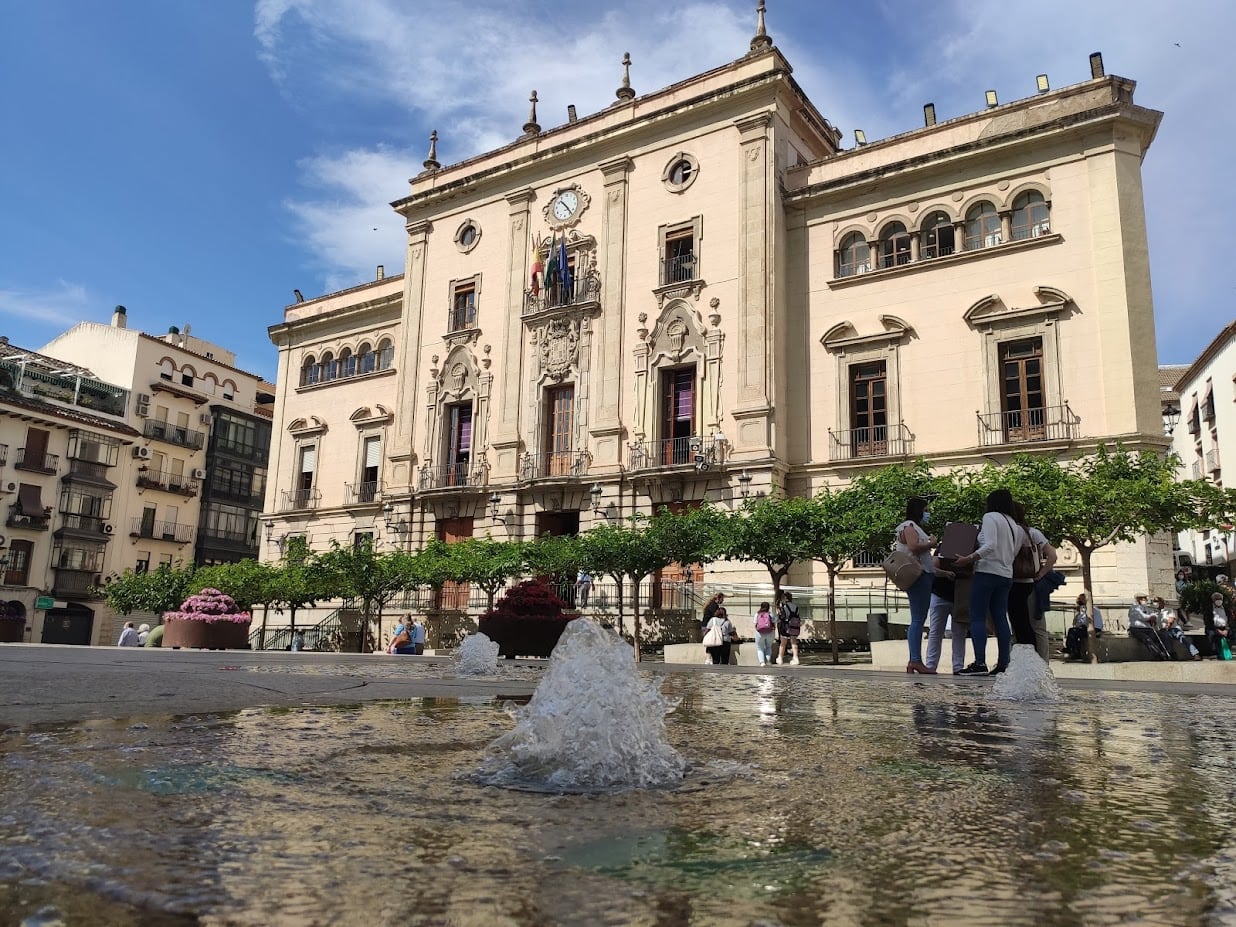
489, 189, 535, 482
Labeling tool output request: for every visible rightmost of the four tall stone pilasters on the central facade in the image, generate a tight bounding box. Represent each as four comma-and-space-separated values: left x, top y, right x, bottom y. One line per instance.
732, 112, 776, 456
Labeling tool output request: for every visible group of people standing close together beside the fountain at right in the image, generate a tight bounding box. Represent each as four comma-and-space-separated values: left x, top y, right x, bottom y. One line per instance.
894, 489, 1057, 676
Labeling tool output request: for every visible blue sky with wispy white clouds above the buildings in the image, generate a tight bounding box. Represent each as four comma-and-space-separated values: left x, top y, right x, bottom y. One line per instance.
0, 0, 1236, 377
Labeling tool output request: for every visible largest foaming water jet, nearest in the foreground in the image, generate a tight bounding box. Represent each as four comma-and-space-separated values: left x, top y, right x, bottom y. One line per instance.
476, 618, 687, 792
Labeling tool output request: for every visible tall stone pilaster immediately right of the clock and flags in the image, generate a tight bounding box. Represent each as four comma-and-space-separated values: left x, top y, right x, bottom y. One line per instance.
581, 157, 634, 473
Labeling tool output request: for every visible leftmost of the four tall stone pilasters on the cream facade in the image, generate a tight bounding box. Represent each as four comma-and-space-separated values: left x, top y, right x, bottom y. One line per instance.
395, 220, 434, 496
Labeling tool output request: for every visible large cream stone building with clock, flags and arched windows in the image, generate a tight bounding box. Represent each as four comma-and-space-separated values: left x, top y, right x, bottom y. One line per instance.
263, 27, 1170, 605
